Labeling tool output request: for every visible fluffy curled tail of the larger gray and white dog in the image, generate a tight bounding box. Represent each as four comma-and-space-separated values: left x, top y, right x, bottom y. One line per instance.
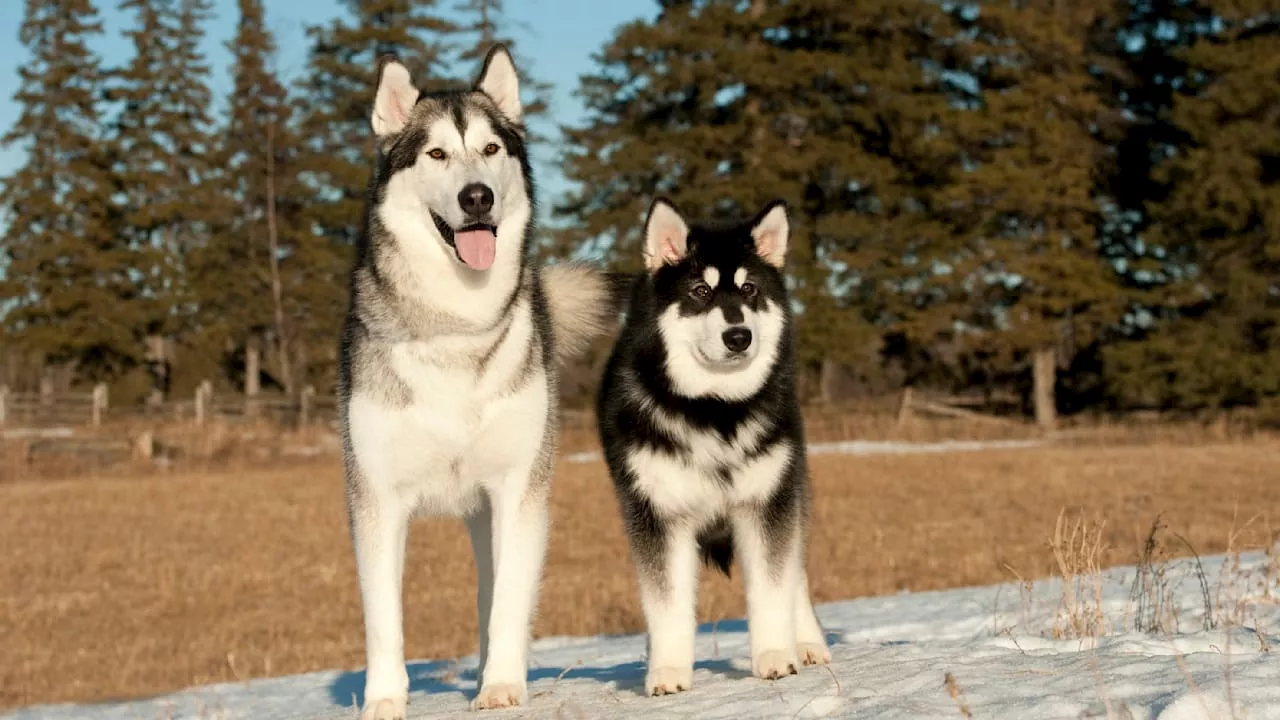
541, 263, 634, 361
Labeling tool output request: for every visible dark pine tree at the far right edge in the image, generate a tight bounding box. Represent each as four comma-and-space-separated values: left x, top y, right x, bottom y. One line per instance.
1107, 0, 1280, 411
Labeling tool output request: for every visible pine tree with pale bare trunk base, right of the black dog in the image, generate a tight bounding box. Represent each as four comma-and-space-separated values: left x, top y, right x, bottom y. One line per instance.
893, 0, 1124, 425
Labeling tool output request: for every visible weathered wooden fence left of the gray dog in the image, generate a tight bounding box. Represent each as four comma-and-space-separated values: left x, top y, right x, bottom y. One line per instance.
0, 380, 337, 427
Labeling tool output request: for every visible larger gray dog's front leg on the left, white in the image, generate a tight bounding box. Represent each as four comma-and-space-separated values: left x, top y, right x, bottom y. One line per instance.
348, 483, 408, 720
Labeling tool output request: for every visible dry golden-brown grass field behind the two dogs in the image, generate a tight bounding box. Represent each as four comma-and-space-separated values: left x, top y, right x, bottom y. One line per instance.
0, 441, 1280, 707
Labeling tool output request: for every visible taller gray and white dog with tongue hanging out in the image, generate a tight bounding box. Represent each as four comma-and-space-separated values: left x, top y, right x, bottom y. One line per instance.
338, 46, 621, 720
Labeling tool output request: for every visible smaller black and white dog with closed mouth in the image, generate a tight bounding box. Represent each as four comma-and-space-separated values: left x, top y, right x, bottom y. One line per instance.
598, 193, 831, 694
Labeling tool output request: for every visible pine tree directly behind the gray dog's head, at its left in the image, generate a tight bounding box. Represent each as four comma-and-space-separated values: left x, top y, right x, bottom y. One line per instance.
280, 0, 456, 387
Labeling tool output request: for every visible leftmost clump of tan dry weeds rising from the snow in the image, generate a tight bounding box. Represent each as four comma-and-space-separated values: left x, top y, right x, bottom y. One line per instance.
1050, 509, 1107, 639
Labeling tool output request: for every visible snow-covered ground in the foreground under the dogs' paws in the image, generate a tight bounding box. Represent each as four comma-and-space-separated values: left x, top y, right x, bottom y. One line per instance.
4, 543, 1280, 720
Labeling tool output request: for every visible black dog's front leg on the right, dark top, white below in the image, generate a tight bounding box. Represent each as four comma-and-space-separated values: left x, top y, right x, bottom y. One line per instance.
732, 506, 801, 680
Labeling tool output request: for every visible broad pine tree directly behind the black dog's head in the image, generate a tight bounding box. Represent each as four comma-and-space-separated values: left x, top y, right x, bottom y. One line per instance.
557, 0, 950, 394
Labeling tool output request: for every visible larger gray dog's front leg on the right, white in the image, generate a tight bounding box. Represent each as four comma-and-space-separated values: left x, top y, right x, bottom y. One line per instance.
472, 470, 550, 710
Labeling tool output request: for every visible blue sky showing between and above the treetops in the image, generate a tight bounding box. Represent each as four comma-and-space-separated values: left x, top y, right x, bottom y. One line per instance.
0, 0, 657, 221
